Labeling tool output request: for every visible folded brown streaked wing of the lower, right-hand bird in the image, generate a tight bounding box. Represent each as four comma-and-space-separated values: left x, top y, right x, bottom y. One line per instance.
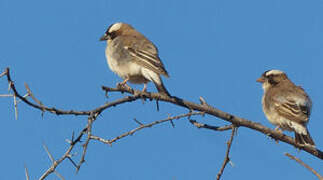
273, 90, 311, 124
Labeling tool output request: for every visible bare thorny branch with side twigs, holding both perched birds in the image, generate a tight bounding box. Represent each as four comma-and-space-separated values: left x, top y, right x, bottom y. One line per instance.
0, 68, 323, 180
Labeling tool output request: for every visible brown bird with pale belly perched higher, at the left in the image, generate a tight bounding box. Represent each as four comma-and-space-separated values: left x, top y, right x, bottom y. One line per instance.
100, 22, 170, 96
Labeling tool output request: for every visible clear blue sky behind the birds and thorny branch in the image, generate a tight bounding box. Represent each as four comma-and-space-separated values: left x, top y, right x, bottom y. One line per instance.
0, 0, 323, 180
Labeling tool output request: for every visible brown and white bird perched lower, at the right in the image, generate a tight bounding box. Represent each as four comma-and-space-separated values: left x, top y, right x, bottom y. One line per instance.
257, 70, 315, 146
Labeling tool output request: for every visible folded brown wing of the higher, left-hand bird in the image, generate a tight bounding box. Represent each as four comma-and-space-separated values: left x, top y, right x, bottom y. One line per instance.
124, 36, 169, 77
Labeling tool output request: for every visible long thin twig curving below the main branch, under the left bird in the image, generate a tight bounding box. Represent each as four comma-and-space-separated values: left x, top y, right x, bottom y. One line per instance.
90, 112, 203, 145
